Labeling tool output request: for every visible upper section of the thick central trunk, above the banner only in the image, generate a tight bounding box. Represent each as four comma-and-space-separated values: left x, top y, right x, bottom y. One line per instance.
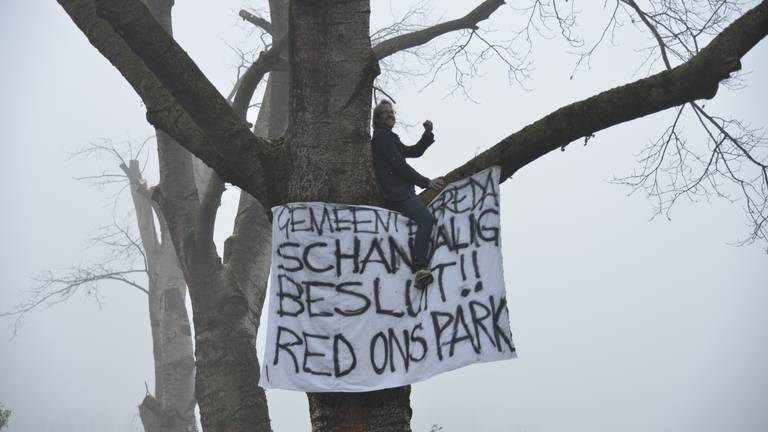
287, 0, 379, 204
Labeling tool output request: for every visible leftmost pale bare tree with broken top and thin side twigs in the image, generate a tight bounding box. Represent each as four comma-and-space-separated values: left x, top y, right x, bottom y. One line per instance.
2, 142, 197, 432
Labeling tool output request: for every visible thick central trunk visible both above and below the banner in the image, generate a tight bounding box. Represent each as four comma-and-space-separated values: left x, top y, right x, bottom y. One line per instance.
287, 0, 411, 431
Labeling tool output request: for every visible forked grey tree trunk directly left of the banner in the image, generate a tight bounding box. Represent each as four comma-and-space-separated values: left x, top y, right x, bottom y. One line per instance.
140, 0, 271, 432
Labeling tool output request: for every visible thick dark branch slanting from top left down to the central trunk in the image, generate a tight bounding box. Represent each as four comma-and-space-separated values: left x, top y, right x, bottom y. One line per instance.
58, 0, 276, 208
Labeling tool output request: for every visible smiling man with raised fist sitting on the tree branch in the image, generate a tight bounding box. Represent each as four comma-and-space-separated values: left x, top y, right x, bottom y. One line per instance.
371, 99, 445, 288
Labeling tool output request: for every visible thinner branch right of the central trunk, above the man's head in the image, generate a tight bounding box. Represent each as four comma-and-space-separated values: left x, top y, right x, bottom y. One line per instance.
373, 0, 504, 60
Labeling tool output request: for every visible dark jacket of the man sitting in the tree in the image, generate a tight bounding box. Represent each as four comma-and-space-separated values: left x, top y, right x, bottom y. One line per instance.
371, 128, 435, 201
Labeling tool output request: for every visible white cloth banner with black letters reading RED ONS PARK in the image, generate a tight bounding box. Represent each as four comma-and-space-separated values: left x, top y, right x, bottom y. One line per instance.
259, 167, 515, 392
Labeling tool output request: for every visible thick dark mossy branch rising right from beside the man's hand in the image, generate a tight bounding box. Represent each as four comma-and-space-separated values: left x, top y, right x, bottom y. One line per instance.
422, 0, 768, 199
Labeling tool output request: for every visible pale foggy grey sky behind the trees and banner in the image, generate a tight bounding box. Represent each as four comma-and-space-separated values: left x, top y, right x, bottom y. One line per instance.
0, 0, 768, 432
